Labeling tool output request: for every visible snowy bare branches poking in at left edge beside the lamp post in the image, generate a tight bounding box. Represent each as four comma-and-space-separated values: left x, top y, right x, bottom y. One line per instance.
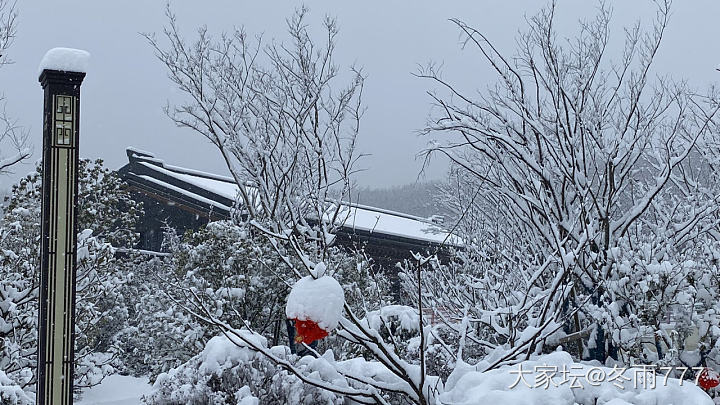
0, 0, 30, 174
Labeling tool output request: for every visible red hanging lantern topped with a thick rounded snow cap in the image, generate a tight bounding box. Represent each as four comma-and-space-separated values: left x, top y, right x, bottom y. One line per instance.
285, 263, 345, 344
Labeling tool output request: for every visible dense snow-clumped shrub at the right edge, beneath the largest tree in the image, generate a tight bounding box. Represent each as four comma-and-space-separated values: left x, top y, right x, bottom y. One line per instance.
586, 240, 720, 376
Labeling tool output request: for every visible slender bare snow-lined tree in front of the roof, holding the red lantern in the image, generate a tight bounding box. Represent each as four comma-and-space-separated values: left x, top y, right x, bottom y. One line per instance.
147, 9, 452, 403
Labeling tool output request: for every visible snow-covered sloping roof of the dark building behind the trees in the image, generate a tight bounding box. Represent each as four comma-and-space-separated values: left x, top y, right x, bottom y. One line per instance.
119, 148, 462, 246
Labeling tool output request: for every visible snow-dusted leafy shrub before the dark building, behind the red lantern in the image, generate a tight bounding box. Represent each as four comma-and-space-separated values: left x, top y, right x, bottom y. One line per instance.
125, 221, 389, 379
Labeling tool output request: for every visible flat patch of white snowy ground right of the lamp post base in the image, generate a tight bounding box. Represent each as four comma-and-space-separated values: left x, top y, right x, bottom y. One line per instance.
75, 375, 152, 405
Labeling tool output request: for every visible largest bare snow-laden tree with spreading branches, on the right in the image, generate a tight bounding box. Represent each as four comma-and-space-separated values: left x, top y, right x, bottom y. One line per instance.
419, 1, 720, 369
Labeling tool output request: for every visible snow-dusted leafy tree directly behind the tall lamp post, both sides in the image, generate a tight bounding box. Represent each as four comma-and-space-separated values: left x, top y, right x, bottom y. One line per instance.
0, 160, 141, 390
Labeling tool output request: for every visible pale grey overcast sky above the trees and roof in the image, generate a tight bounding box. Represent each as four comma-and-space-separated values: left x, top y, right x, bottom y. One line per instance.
0, 0, 720, 189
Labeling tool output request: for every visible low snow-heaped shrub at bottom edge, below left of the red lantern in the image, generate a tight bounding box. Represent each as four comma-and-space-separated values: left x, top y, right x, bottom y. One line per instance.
145, 335, 344, 405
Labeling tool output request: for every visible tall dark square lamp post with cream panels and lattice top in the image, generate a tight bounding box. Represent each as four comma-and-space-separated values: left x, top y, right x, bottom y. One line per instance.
36, 51, 87, 405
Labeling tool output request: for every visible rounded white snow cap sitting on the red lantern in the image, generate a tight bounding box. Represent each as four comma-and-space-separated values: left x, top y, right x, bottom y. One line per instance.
285, 276, 345, 332
